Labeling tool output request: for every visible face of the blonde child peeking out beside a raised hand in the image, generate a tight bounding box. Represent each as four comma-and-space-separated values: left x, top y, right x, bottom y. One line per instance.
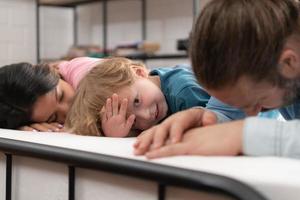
117, 77, 168, 130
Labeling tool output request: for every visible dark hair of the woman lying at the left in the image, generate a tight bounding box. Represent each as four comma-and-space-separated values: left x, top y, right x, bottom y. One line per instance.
0, 63, 59, 129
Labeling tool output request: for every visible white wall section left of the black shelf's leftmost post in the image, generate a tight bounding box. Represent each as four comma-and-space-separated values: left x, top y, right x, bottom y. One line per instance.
0, 0, 36, 66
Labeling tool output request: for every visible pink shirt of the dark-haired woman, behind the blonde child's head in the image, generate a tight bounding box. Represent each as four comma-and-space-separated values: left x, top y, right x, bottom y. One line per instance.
58, 57, 103, 90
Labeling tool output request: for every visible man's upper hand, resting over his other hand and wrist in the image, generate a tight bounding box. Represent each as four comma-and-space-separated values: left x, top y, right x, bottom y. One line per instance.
134, 108, 217, 155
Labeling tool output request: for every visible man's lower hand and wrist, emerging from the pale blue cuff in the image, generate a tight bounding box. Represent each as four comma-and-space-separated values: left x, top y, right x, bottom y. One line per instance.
145, 121, 244, 159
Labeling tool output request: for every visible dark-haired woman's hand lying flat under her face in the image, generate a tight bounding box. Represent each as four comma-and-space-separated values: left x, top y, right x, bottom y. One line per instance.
18, 122, 64, 132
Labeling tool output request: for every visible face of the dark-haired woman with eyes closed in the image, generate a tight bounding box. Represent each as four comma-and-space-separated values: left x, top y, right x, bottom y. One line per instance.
31, 79, 75, 123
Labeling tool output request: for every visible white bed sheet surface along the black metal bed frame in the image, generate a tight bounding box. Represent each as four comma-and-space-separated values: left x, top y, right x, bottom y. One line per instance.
0, 129, 300, 200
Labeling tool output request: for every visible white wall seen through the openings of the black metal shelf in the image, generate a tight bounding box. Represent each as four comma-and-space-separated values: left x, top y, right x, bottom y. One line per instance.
41, 0, 213, 67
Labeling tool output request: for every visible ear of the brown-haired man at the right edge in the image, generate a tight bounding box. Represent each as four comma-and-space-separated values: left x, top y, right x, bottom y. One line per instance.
279, 49, 300, 79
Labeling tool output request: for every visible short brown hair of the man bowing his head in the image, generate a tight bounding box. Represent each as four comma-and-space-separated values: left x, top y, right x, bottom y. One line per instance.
190, 0, 300, 89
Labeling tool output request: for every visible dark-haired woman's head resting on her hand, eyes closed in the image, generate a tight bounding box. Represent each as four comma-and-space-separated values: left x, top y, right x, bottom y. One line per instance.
0, 63, 74, 131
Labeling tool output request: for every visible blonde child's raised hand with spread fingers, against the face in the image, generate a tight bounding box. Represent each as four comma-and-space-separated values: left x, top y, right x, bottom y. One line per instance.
101, 94, 135, 137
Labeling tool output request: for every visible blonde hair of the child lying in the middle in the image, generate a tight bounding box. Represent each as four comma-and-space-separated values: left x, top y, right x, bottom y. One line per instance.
65, 58, 146, 136
